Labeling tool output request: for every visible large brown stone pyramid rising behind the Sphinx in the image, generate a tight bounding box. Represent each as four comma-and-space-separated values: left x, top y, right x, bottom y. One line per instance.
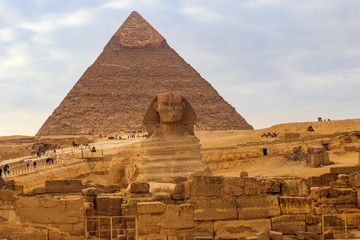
36, 12, 253, 136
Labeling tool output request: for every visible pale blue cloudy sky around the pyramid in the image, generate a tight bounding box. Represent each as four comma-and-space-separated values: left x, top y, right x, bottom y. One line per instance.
0, 0, 360, 136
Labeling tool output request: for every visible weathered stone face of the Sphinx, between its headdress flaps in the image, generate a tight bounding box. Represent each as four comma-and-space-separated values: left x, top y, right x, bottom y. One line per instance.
157, 94, 184, 123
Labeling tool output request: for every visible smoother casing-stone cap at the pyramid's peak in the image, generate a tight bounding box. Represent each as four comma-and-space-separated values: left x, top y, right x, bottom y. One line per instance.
114, 11, 166, 47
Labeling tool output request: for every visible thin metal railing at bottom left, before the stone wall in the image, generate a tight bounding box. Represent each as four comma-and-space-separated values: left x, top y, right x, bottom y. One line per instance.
85, 216, 138, 240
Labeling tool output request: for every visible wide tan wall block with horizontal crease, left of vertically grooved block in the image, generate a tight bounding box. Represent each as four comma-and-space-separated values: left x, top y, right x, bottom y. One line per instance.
236, 196, 280, 219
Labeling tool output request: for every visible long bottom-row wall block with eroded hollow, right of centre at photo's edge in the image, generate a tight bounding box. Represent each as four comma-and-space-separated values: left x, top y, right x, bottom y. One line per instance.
214, 219, 271, 239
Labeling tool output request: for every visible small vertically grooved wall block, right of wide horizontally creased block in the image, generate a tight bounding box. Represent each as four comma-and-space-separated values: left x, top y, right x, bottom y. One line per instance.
279, 197, 311, 214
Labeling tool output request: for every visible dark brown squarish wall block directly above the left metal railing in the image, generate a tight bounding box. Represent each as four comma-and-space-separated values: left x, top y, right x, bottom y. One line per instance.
96, 195, 123, 216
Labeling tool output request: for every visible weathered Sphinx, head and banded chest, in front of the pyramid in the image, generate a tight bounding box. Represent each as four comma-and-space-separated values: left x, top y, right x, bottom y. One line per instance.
134, 93, 211, 183
